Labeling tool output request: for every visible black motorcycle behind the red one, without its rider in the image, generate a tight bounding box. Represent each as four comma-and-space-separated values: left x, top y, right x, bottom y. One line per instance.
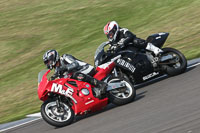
94, 33, 187, 84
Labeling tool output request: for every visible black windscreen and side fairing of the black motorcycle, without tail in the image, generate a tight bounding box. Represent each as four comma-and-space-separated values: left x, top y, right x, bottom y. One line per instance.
94, 43, 153, 83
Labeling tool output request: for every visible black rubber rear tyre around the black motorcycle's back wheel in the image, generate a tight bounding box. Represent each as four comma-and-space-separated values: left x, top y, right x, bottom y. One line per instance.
163, 48, 187, 76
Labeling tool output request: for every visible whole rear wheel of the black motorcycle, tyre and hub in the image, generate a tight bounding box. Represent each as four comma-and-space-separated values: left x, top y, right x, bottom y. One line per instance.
162, 48, 187, 76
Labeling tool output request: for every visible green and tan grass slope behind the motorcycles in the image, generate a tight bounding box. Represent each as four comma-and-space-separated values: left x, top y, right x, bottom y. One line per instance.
0, 0, 200, 123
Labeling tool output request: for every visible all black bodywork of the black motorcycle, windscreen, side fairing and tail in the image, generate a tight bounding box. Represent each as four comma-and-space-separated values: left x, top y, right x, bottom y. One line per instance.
94, 32, 169, 84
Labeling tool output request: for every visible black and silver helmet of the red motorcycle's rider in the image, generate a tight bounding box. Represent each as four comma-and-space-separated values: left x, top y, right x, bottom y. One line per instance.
43, 50, 60, 70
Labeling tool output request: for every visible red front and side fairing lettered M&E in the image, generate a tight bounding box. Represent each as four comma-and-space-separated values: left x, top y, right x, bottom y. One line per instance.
38, 71, 108, 114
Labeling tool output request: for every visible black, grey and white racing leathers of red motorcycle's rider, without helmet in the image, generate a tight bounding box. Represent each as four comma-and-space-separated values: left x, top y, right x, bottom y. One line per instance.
51, 54, 107, 97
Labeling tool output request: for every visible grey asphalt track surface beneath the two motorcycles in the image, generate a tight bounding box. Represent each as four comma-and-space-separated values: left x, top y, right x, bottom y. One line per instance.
2, 66, 200, 133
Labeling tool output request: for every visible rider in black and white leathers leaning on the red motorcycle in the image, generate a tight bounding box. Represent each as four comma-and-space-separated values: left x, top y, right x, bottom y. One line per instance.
43, 50, 107, 98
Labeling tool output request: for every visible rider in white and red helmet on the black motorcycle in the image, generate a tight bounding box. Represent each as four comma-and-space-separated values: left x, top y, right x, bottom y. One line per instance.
104, 21, 162, 56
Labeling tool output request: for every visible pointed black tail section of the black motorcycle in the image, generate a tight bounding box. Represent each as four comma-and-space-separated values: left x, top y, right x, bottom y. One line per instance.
147, 32, 169, 48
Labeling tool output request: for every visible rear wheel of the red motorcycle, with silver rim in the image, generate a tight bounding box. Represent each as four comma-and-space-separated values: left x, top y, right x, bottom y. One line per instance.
108, 77, 136, 105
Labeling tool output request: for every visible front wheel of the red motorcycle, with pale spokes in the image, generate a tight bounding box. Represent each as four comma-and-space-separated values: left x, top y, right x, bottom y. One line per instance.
41, 100, 74, 127
